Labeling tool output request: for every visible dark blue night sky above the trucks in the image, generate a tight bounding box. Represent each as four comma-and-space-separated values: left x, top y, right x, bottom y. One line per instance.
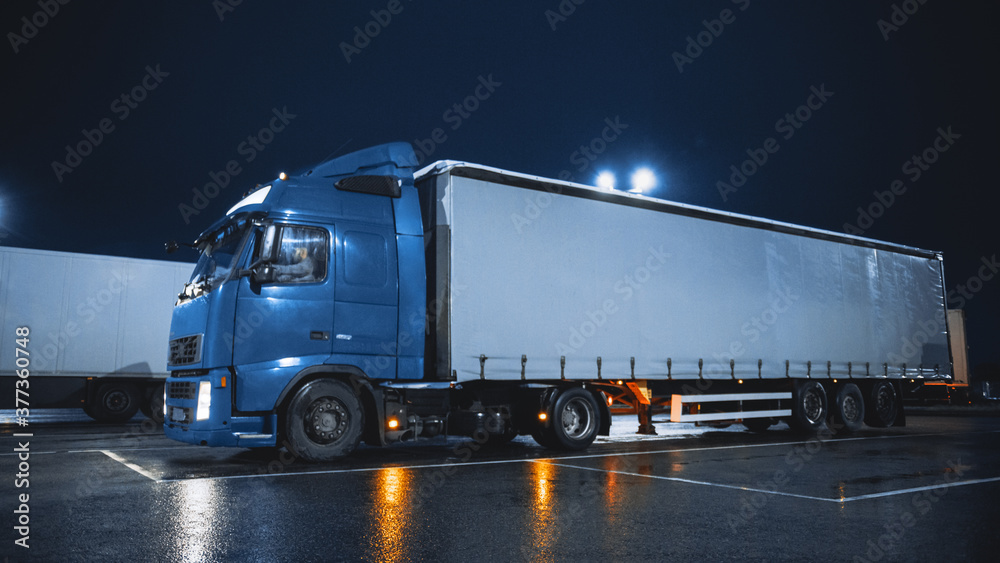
0, 0, 1000, 365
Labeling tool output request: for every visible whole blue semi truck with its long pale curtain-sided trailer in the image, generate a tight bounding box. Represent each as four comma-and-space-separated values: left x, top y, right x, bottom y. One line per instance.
164, 143, 951, 461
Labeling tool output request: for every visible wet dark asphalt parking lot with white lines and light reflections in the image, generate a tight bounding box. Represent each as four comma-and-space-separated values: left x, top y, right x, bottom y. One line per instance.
0, 414, 1000, 561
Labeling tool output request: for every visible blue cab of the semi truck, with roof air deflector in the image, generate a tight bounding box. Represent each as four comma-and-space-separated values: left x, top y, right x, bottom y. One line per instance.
164, 143, 426, 458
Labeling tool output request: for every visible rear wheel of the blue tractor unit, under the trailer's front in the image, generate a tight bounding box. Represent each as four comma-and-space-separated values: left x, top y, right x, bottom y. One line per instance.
532, 387, 601, 450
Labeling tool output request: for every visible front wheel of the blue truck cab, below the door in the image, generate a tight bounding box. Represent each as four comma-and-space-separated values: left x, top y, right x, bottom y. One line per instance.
285, 379, 365, 461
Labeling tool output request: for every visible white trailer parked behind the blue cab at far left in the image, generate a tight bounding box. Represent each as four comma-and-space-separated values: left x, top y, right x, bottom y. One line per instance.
0, 247, 192, 421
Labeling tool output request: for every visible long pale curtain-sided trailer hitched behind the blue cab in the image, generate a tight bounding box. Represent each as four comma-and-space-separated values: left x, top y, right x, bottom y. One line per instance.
417, 162, 951, 434
